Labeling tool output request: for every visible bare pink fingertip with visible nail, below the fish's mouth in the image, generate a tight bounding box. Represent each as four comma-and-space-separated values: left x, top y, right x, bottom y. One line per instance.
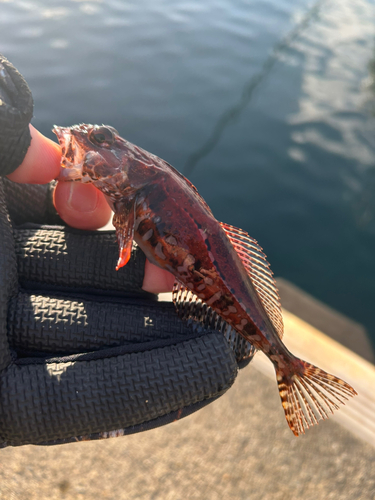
53, 182, 112, 230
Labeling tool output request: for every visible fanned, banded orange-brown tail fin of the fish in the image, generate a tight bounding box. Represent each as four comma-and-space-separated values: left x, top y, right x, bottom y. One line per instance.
276, 361, 357, 436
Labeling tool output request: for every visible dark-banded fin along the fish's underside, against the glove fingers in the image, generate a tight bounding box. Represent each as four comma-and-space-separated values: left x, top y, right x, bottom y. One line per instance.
172, 280, 256, 362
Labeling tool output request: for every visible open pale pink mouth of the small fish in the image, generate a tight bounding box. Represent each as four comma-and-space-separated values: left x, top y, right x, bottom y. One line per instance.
52, 125, 90, 182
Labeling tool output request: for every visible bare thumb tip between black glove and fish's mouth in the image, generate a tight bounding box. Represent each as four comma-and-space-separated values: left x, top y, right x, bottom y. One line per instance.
7, 124, 61, 184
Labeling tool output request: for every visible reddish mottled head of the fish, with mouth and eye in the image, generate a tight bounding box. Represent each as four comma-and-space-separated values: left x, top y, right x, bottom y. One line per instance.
53, 124, 163, 198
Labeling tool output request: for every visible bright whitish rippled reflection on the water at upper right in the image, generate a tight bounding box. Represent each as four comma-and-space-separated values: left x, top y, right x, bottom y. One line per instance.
288, 0, 375, 165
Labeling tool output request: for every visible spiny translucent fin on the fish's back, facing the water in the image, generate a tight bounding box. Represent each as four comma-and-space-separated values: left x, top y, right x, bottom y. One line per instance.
220, 222, 284, 338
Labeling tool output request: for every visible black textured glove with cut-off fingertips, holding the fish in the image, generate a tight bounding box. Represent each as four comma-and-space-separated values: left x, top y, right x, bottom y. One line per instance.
0, 56, 253, 447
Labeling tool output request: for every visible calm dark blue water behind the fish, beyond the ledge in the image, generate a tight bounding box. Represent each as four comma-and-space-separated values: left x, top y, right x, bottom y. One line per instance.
0, 0, 375, 342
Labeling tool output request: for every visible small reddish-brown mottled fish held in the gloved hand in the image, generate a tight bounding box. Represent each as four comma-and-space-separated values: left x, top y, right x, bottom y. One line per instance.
53, 124, 357, 436
